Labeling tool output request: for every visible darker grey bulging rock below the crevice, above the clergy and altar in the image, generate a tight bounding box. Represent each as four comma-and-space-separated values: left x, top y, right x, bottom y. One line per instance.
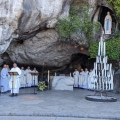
7, 29, 88, 67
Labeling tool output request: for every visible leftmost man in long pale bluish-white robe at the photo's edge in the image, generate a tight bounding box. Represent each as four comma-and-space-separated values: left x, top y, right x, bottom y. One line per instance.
1, 64, 9, 92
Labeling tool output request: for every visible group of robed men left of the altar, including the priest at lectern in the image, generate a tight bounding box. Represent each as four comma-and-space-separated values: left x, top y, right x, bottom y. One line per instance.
0, 63, 38, 95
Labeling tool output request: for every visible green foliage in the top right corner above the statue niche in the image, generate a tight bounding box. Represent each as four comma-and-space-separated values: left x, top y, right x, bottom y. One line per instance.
108, 0, 120, 23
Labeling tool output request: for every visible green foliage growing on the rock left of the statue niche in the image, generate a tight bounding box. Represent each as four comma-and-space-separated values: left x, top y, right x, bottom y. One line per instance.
56, 6, 100, 41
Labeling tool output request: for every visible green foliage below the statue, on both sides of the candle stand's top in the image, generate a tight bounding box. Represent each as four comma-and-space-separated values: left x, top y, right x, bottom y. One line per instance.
89, 33, 120, 60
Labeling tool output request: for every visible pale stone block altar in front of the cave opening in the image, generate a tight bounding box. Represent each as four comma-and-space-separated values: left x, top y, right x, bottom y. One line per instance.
52, 76, 74, 91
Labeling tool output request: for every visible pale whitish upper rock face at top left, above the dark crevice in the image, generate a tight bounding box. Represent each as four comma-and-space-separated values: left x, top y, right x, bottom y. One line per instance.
0, 0, 72, 54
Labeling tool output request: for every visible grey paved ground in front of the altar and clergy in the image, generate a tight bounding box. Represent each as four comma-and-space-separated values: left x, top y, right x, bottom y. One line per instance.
0, 88, 120, 120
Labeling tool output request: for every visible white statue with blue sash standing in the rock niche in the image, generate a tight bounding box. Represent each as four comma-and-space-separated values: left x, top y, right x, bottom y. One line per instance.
104, 12, 112, 34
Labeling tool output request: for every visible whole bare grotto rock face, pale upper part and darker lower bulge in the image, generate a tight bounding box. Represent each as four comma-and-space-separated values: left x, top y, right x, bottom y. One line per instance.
0, 0, 116, 67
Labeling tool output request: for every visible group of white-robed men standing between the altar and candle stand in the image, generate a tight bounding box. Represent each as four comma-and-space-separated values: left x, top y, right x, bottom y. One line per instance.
73, 68, 94, 89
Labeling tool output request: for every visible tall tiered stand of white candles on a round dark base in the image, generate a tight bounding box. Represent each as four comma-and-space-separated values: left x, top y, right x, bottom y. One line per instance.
85, 37, 117, 102
